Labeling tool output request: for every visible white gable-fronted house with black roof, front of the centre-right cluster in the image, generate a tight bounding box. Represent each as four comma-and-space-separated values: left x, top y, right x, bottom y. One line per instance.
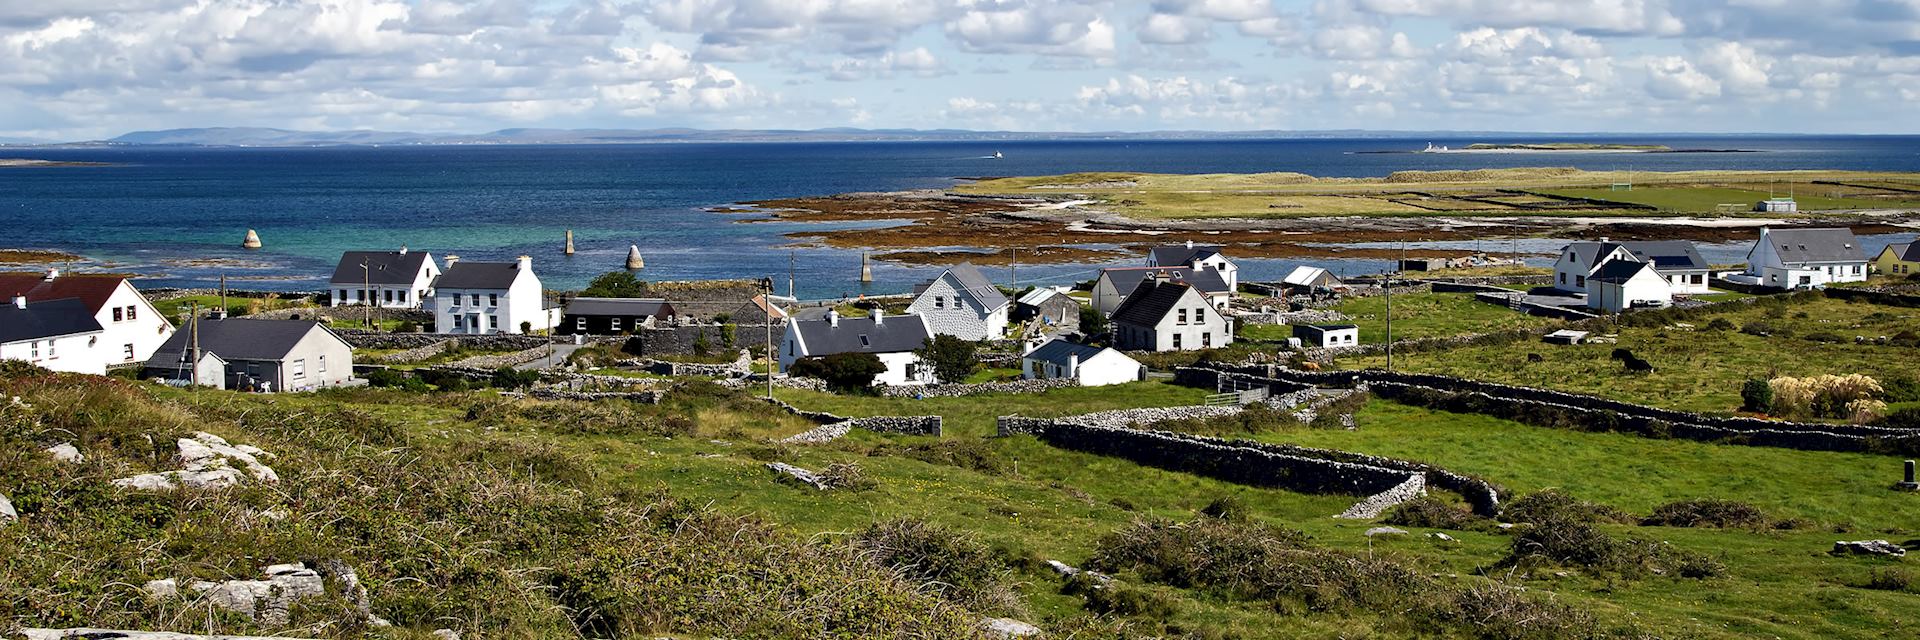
1112, 279, 1233, 352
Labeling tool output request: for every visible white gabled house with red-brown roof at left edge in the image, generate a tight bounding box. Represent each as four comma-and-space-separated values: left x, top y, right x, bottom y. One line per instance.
0, 269, 173, 367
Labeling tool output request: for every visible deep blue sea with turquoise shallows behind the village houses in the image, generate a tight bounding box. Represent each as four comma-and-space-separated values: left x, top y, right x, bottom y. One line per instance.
0, 135, 1920, 298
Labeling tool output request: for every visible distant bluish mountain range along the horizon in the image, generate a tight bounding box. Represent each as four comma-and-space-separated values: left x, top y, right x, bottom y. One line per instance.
23, 127, 1827, 146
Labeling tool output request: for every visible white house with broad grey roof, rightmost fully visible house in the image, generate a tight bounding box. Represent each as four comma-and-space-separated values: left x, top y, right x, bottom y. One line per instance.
1745, 229, 1866, 288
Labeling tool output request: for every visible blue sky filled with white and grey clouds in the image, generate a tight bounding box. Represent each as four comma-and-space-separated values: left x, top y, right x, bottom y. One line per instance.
0, 0, 1920, 140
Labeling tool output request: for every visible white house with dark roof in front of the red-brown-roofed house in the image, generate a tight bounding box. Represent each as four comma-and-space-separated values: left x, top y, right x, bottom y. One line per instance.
0, 294, 108, 375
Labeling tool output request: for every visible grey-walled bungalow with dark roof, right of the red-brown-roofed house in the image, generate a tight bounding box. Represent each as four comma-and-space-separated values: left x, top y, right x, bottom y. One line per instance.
146, 317, 353, 392
